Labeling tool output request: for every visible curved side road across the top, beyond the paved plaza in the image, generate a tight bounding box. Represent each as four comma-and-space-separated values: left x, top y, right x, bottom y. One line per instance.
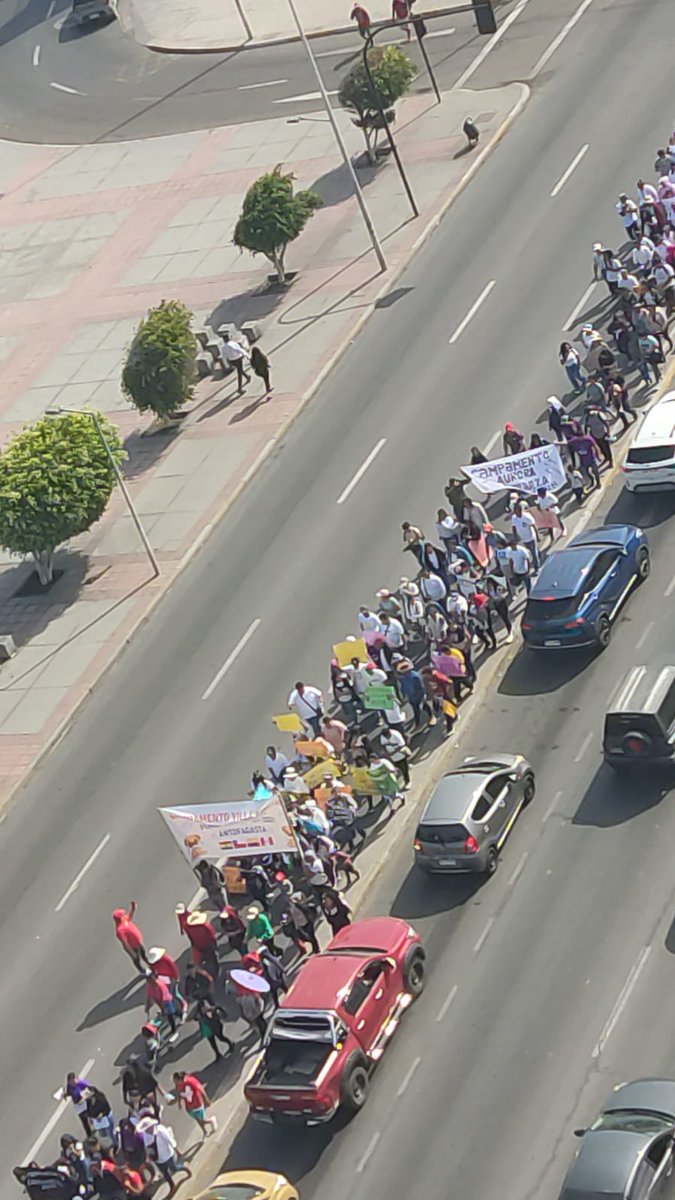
0, 0, 578, 144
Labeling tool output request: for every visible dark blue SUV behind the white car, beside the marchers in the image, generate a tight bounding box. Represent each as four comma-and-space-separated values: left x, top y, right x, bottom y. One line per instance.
521, 524, 651, 650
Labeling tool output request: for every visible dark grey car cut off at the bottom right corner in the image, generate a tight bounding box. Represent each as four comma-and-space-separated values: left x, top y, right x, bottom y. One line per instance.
560, 1079, 675, 1200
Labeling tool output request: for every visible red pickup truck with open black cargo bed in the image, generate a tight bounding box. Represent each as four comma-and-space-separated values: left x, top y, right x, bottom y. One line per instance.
244, 917, 425, 1124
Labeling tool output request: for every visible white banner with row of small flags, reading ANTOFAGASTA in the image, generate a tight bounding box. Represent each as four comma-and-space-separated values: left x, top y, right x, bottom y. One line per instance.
159, 785, 298, 864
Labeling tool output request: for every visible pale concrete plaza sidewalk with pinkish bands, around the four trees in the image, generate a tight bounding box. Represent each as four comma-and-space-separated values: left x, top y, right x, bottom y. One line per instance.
0, 84, 528, 805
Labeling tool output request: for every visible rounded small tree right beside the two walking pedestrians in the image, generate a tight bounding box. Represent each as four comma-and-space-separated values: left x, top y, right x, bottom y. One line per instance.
121, 300, 197, 416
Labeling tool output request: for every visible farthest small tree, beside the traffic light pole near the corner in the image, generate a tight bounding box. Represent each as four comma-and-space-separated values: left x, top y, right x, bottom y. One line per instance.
338, 46, 414, 163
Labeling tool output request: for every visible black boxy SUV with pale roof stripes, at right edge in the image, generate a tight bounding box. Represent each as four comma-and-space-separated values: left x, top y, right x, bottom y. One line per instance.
603, 666, 675, 770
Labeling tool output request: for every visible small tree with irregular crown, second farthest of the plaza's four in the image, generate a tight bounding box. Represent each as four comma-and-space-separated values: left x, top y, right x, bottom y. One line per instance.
233, 166, 323, 283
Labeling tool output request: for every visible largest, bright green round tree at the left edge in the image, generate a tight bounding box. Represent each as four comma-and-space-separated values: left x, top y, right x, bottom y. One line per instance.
0, 413, 126, 584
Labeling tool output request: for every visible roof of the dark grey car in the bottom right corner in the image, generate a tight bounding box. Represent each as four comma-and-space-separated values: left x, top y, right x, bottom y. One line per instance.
561, 1129, 653, 1200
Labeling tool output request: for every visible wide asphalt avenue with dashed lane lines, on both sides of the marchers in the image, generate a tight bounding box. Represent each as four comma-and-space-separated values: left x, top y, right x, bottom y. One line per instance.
0, 0, 675, 1200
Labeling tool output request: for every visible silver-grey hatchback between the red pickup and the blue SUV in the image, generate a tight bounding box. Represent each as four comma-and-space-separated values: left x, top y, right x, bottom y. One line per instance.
414, 754, 534, 875
